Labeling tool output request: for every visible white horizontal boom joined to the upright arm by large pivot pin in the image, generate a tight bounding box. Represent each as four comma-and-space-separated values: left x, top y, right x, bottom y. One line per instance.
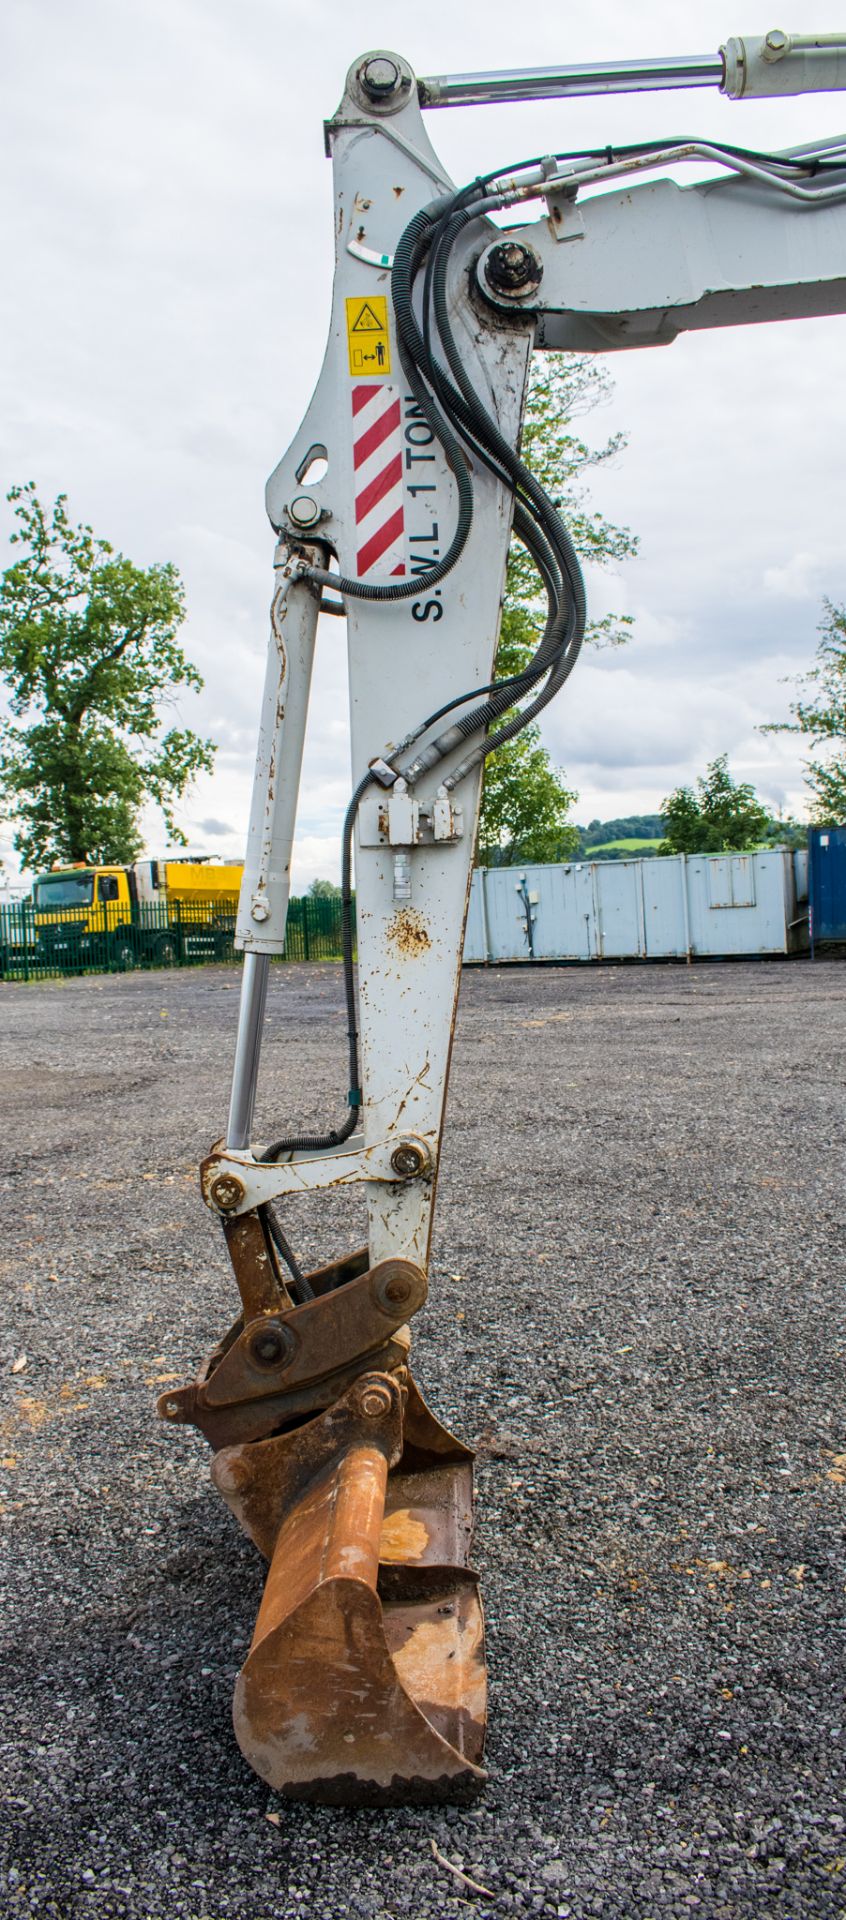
476, 142, 846, 353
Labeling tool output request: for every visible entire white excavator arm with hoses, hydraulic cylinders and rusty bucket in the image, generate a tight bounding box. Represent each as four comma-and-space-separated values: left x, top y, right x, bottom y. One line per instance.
159, 35, 846, 1805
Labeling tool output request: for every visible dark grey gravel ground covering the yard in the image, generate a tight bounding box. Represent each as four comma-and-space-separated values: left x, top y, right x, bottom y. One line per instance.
0, 960, 846, 1920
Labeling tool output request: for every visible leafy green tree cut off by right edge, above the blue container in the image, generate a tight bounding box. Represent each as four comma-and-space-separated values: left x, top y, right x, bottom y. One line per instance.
762, 599, 846, 828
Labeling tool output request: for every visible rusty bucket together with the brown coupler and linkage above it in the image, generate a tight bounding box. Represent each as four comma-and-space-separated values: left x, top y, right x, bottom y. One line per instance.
159, 1251, 485, 1807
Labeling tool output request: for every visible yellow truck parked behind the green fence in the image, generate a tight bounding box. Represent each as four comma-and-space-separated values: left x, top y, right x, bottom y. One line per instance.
33, 854, 244, 972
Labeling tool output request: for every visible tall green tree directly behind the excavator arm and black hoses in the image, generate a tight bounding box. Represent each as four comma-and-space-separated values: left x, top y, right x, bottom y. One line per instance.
478, 353, 637, 866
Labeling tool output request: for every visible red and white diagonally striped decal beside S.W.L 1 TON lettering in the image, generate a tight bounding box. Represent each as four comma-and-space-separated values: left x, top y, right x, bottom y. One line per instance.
353, 380, 405, 580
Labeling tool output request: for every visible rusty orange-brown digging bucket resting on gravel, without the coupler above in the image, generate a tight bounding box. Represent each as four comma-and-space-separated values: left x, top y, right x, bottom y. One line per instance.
213, 1373, 485, 1805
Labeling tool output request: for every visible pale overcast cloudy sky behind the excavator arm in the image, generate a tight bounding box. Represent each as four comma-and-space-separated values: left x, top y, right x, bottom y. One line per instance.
0, 0, 846, 887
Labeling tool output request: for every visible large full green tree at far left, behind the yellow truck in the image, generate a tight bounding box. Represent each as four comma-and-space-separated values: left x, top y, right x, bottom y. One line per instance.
0, 482, 215, 866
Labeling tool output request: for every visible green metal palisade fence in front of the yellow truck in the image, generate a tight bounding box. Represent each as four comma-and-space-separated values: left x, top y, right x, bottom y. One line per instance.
0, 895, 349, 981
